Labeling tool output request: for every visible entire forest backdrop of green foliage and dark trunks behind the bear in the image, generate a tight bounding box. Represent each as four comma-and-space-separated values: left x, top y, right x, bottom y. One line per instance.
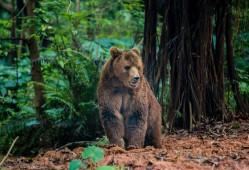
0, 0, 249, 154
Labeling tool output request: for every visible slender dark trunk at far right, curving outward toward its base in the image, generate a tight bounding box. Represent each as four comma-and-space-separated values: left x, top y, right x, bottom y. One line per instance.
225, 0, 249, 117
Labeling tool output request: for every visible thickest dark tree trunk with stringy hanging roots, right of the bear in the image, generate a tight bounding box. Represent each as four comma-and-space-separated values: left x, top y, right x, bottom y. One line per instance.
168, 0, 225, 130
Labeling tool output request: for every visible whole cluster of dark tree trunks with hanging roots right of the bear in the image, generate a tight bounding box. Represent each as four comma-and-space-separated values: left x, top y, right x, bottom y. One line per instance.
146, 0, 248, 131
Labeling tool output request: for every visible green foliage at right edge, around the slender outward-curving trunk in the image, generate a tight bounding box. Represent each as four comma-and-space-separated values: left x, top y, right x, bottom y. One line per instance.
225, 3, 249, 109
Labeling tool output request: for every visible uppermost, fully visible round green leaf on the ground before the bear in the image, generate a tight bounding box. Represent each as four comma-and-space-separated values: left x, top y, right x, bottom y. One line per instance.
81, 146, 104, 162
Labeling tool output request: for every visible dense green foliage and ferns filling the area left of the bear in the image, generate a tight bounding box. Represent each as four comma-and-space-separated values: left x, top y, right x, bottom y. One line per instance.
0, 0, 144, 152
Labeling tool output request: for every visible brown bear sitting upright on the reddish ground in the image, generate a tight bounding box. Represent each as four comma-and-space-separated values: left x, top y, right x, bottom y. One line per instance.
98, 47, 161, 149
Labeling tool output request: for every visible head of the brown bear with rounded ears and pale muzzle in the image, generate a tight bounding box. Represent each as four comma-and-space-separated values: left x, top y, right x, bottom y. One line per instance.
110, 47, 143, 89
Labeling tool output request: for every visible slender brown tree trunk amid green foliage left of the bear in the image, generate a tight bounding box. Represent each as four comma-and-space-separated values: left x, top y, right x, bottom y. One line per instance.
26, 0, 46, 123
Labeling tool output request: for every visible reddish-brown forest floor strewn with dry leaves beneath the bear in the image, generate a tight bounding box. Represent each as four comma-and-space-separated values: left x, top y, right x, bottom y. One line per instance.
3, 121, 249, 170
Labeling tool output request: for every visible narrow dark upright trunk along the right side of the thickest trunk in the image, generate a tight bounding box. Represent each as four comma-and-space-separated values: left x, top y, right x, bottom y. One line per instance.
206, 1, 226, 120
